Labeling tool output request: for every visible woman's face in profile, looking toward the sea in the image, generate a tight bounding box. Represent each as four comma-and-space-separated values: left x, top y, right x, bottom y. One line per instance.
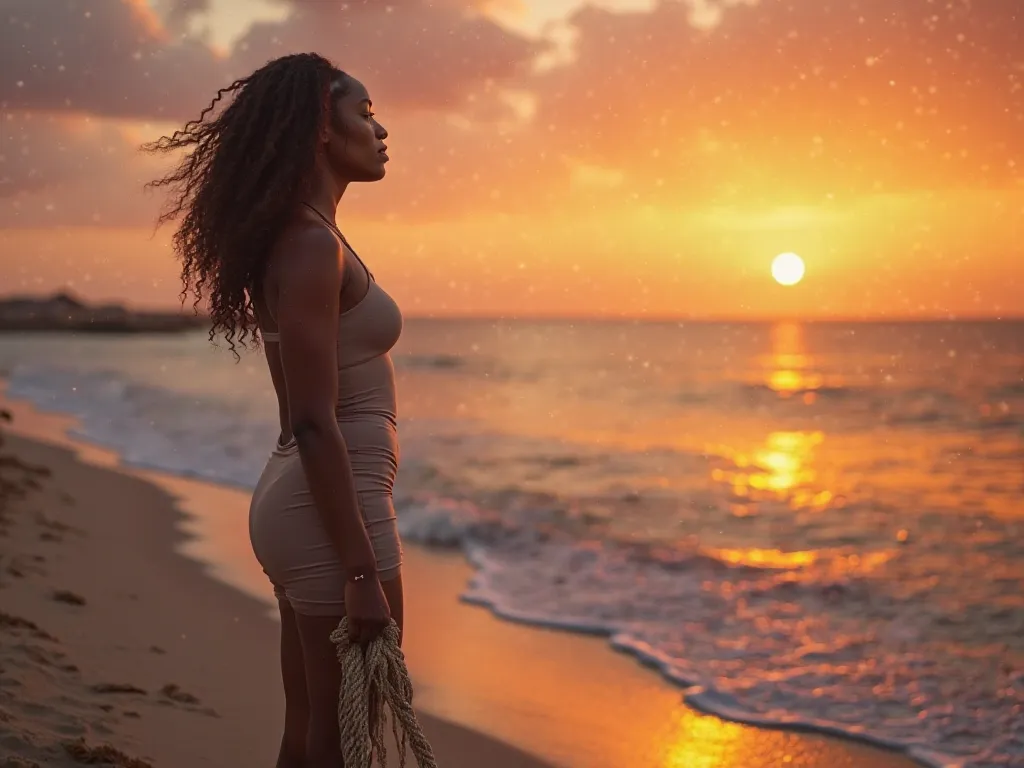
325, 76, 388, 182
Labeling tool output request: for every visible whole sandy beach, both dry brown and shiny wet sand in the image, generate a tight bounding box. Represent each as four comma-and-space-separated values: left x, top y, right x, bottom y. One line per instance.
0, 391, 913, 768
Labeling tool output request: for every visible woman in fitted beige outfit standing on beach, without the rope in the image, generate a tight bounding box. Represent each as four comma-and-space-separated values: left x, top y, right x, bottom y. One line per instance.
145, 53, 402, 768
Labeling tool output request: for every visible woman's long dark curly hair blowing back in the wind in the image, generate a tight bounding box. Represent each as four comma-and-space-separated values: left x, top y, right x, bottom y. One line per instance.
141, 53, 347, 359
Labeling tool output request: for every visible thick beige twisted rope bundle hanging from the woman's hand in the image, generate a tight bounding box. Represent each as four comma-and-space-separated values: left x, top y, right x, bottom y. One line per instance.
331, 618, 437, 768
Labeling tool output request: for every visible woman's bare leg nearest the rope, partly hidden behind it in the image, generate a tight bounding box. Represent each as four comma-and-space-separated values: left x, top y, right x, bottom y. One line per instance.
296, 575, 404, 768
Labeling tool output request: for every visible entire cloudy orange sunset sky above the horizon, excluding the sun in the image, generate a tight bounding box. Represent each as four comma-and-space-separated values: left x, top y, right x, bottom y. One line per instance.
0, 0, 1024, 317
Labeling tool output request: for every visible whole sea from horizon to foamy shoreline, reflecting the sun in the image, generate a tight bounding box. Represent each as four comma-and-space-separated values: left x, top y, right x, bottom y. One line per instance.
0, 318, 1024, 768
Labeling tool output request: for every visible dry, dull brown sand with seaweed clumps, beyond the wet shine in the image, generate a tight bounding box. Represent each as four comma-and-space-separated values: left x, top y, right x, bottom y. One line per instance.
0, 409, 561, 768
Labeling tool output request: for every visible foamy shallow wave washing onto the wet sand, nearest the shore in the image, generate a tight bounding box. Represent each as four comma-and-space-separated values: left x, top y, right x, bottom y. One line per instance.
399, 500, 1024, 768
